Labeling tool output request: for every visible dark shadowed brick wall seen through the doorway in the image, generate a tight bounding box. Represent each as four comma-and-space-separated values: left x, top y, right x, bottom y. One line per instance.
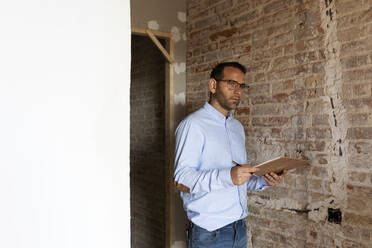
131, 36, 166, 248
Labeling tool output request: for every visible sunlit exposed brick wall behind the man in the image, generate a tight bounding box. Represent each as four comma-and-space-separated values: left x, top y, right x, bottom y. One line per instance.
186, 0, 372, 248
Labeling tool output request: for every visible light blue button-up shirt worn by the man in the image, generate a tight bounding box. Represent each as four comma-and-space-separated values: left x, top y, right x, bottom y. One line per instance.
174, 103, 268, 231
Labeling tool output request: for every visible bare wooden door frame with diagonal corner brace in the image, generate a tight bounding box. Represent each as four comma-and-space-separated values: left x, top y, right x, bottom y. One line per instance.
132, 27, 175, 248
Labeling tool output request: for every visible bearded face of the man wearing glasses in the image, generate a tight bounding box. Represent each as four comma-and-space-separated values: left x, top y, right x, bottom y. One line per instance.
214, 67, 244, 111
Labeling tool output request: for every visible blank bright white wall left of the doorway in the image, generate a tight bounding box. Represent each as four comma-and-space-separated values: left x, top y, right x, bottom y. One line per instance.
0, 0, 130, 248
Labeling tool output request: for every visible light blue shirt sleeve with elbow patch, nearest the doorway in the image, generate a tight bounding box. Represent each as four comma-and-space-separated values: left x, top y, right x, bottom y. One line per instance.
174, 119, 234, 193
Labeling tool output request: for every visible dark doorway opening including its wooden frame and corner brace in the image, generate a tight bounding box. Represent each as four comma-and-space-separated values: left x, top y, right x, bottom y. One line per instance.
130, 29, 174, 248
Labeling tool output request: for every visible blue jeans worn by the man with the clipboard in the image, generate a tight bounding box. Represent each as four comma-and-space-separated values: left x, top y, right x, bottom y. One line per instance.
187, 219, 247, 248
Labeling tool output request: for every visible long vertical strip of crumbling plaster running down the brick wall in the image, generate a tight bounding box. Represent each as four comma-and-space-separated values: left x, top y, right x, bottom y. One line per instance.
313, 0, 350, 219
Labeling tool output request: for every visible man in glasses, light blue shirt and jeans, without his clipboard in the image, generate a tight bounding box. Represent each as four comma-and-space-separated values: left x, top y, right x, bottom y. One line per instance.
174, 62, 285, 248
